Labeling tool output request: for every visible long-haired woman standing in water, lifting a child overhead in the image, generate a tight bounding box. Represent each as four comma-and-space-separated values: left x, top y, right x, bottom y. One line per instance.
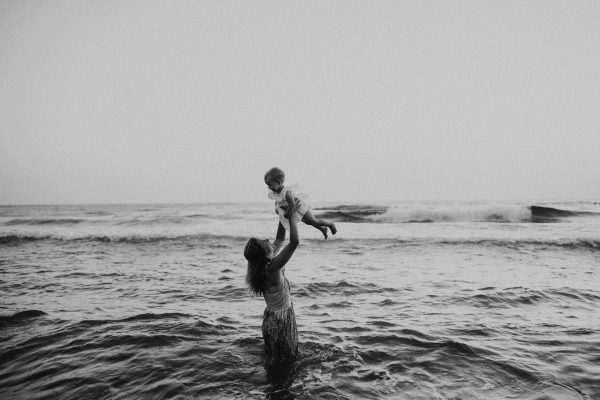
244, 218, 300, 364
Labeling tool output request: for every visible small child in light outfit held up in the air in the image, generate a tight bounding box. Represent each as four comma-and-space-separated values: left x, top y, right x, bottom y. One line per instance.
265, 168, 337, 239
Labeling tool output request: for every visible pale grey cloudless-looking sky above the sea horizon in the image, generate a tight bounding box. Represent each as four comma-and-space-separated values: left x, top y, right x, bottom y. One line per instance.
0, 0, 600, 204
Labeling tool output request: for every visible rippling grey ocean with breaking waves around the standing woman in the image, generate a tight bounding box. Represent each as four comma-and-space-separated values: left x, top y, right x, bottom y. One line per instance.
0, 201, 600, 400
